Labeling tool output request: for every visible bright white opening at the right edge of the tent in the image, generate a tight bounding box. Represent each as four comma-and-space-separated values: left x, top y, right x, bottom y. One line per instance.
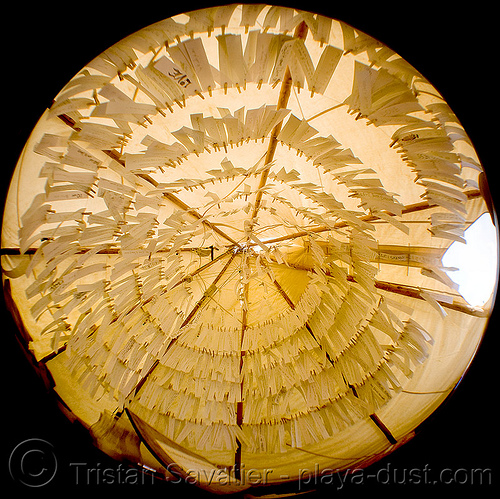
442, 213, 498, 307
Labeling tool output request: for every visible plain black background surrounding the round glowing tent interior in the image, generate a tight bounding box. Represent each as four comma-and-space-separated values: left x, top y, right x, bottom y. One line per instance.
0, 1, 500, 497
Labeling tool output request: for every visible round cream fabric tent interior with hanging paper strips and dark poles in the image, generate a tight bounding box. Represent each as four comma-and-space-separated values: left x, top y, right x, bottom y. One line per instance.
2, 5, 496, 492
